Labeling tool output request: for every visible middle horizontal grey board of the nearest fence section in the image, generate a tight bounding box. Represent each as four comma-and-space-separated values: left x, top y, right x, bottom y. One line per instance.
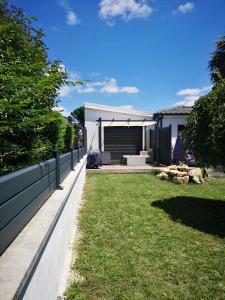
0, 171, 56, 229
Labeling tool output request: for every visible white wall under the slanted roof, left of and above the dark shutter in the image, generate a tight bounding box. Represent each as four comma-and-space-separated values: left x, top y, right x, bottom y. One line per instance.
85, 107, 152, 150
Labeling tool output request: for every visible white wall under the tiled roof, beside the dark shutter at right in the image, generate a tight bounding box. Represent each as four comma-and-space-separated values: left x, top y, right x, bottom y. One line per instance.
162, 115, 187, 150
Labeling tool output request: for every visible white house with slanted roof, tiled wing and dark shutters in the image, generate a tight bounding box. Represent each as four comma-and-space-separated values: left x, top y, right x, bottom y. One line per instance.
85, 103, 191, 164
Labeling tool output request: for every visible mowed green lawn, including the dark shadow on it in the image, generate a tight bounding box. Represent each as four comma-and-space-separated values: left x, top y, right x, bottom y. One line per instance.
67, 174, 225, 300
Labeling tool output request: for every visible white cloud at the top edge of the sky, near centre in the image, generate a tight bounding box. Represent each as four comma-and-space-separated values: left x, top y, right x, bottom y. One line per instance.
99, 0, 153, 26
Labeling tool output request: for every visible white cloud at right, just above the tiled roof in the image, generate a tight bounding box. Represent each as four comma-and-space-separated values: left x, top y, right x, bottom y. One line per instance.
175, 85, 212, 106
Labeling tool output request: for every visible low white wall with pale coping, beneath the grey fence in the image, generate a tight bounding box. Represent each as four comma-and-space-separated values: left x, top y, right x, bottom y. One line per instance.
0, 156, 86, 300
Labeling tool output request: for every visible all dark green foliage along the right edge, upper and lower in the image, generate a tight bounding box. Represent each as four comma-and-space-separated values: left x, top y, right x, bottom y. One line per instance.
185, 37, 225, 167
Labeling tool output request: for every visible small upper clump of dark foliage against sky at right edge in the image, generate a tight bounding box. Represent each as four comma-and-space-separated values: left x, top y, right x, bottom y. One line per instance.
209, 36, 225, 83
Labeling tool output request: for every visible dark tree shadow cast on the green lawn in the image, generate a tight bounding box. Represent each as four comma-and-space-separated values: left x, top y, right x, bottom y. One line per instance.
151, 197, 225, 238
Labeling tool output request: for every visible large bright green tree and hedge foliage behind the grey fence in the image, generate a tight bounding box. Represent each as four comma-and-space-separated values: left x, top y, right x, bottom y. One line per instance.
0, 0, 79, 174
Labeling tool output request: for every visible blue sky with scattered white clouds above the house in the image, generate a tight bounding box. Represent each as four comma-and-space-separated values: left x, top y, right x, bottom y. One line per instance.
10, 0, 225, 111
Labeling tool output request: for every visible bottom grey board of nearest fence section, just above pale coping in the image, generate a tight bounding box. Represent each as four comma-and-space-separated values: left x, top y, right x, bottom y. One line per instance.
0, 182, 56, 255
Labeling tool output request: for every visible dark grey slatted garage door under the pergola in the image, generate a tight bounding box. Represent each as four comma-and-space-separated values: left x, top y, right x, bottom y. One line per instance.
104, 126, 142, 160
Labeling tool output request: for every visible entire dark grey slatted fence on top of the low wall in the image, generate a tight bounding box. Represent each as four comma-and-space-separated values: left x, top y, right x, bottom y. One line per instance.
0, 149, 84, 254
